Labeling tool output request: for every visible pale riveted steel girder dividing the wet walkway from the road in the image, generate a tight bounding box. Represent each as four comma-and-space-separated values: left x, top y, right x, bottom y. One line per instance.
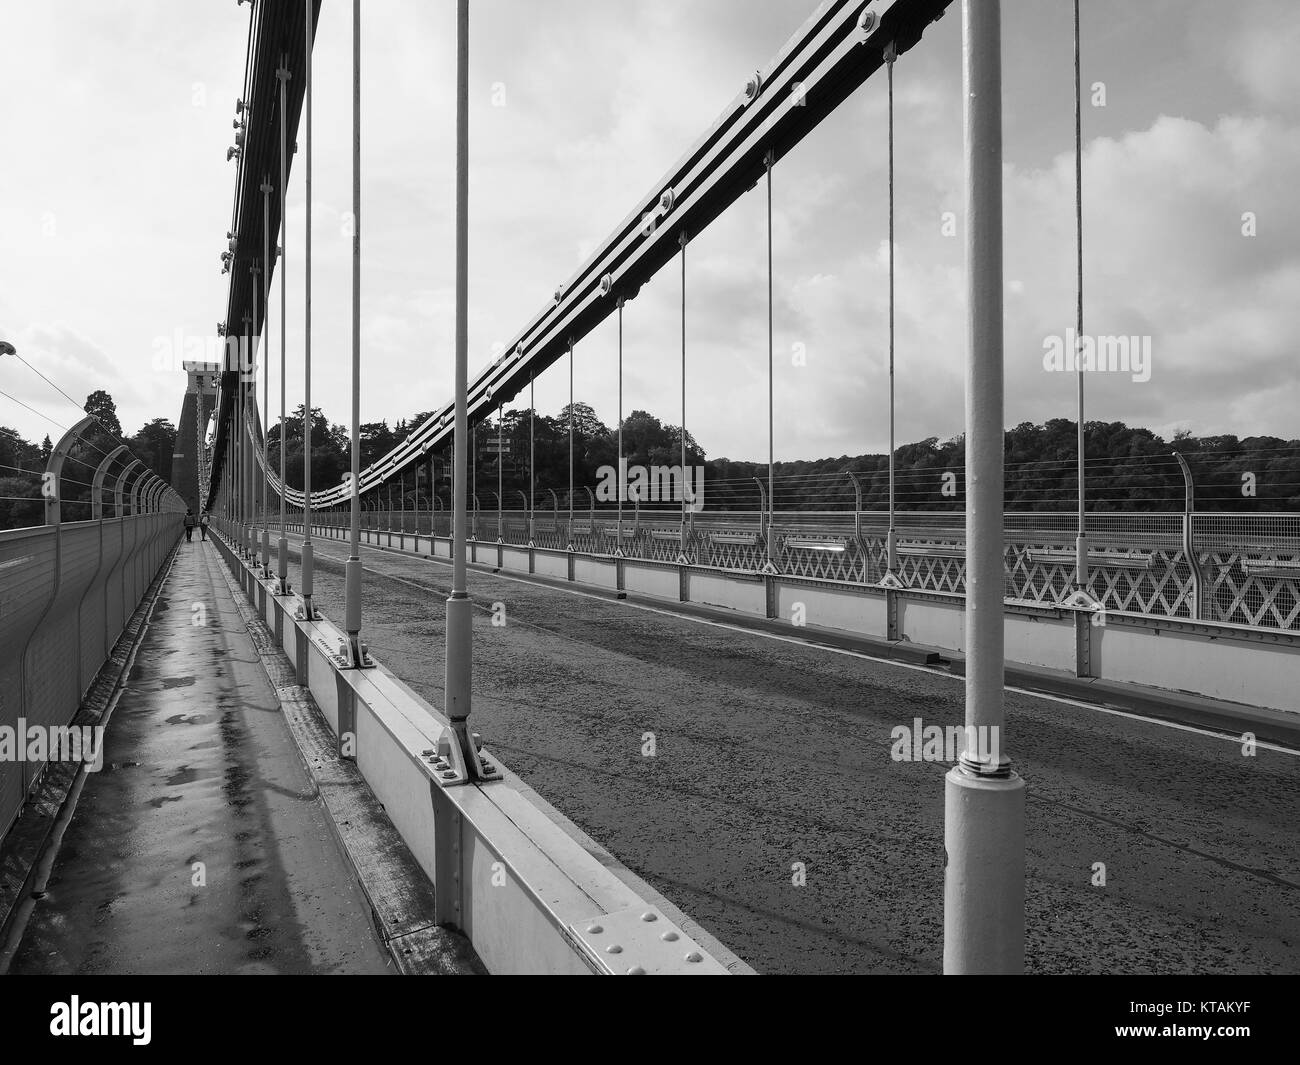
213, 523, 753, 974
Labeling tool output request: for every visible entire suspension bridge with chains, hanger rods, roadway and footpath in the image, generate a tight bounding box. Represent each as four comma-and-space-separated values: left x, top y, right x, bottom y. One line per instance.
0, 0, 1300, 974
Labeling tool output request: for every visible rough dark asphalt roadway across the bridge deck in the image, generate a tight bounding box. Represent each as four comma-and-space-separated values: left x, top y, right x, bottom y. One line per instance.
279, 527, 1300, 973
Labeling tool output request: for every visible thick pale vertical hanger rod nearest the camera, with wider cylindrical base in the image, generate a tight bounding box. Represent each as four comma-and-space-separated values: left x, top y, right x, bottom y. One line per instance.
944, 0, 1024, 974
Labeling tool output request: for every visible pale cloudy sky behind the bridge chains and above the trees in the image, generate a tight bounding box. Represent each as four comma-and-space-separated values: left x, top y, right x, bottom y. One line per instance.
0, 0, 1300, 460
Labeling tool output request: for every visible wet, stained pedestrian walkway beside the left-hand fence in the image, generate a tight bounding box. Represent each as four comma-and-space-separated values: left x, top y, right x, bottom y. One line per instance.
10, 537, 391, 974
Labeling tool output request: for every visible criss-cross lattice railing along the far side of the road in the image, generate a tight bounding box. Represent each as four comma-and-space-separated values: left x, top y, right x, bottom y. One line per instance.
301, 508, 1300, 632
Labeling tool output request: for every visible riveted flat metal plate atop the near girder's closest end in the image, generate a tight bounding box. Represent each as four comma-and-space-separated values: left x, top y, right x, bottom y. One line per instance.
568, 906, 727, 977
